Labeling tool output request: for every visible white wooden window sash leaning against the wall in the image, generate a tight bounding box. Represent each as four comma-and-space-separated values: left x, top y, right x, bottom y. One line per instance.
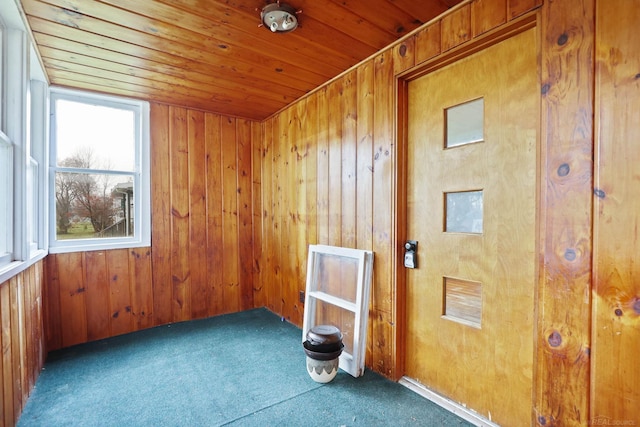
302, 245, 373, 377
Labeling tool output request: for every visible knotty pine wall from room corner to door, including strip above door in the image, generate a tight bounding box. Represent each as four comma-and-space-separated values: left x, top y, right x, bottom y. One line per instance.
255, 0, 540, 378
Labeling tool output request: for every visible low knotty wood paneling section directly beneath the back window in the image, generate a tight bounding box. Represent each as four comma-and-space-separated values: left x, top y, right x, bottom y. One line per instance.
45, 248, 155, 351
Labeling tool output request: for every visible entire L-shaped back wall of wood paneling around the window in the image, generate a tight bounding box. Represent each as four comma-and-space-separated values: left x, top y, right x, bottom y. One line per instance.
45, 104, 261, 350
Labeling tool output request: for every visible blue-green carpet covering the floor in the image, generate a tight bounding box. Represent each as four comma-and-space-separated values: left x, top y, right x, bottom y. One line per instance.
18, 309, 470, 426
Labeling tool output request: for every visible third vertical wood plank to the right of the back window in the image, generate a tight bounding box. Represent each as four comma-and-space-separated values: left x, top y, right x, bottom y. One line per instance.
187, 110, 211, 318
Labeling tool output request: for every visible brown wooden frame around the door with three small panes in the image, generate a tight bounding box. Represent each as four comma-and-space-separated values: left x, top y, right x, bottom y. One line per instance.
392, 10, 542, 422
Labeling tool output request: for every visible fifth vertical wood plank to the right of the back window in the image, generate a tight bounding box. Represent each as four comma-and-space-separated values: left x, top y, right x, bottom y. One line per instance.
220, 118, 240, 313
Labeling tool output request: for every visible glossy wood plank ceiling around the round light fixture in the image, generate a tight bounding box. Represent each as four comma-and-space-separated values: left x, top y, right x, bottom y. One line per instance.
15, 0, 462, 120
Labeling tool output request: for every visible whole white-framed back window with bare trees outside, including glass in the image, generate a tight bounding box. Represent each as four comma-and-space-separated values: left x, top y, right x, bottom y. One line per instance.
49, 88, 151, 253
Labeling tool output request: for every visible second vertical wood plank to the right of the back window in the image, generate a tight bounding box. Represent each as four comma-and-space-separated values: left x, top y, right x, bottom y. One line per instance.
169, 107, 191, 322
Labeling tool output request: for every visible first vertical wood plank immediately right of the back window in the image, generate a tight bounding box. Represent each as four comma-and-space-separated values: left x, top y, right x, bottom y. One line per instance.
150, 104, 172, 324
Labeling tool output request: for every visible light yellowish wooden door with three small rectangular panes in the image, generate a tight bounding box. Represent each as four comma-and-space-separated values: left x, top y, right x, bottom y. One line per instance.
405, 29, 540, 425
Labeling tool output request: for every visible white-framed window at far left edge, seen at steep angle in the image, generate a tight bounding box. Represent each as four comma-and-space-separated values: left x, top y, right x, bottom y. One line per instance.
0, 1, 48, 283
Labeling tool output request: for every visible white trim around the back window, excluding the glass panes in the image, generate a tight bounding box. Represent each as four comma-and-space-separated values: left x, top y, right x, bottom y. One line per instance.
48, 88, 151, 253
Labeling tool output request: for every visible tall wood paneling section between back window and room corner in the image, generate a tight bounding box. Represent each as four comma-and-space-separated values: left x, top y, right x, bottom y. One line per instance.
151, 104, 261, 324
